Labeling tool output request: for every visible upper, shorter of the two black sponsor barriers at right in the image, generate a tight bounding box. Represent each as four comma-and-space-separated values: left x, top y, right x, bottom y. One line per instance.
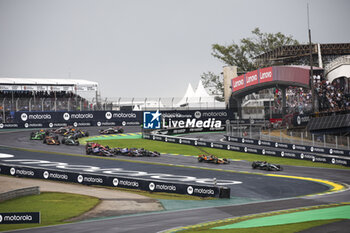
225, 135, 350, 158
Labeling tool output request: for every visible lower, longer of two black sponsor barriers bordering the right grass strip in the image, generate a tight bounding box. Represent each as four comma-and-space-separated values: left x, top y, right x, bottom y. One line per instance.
143, 134, 350, 166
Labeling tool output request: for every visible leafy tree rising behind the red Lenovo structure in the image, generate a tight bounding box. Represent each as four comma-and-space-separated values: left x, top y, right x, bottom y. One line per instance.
201, 28, 299, 99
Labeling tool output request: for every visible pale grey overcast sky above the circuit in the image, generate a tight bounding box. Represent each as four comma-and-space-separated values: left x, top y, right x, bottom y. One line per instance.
0, 0, 350, 99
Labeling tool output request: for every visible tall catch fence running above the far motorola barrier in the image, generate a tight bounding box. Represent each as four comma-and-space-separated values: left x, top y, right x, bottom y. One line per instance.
0, 95, 225, 123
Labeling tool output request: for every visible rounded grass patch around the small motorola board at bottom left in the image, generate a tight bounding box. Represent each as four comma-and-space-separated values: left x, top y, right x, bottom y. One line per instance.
0, 192, 100, 231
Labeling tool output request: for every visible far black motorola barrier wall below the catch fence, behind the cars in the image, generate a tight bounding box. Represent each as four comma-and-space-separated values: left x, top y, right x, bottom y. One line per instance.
0, 109, 233, 129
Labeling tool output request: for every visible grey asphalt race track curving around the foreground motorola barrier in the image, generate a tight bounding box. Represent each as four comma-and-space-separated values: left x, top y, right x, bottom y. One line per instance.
0, 127, 350, 233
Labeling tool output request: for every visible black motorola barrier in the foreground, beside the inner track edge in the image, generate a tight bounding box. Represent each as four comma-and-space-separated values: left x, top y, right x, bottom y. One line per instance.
0, 164, 230, 198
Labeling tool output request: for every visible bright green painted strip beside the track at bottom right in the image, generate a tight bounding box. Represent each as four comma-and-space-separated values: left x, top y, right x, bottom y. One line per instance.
212, 205, 350, 230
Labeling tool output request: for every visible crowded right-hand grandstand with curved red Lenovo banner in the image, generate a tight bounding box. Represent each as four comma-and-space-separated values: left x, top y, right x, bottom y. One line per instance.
224, 43, 350, 140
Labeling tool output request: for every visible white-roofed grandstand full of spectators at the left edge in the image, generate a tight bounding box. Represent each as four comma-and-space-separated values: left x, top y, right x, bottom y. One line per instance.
0, 78, 98, 123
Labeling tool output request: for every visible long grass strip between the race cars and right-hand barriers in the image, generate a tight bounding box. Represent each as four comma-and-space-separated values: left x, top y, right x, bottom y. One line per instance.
89, 139, 350, 170
